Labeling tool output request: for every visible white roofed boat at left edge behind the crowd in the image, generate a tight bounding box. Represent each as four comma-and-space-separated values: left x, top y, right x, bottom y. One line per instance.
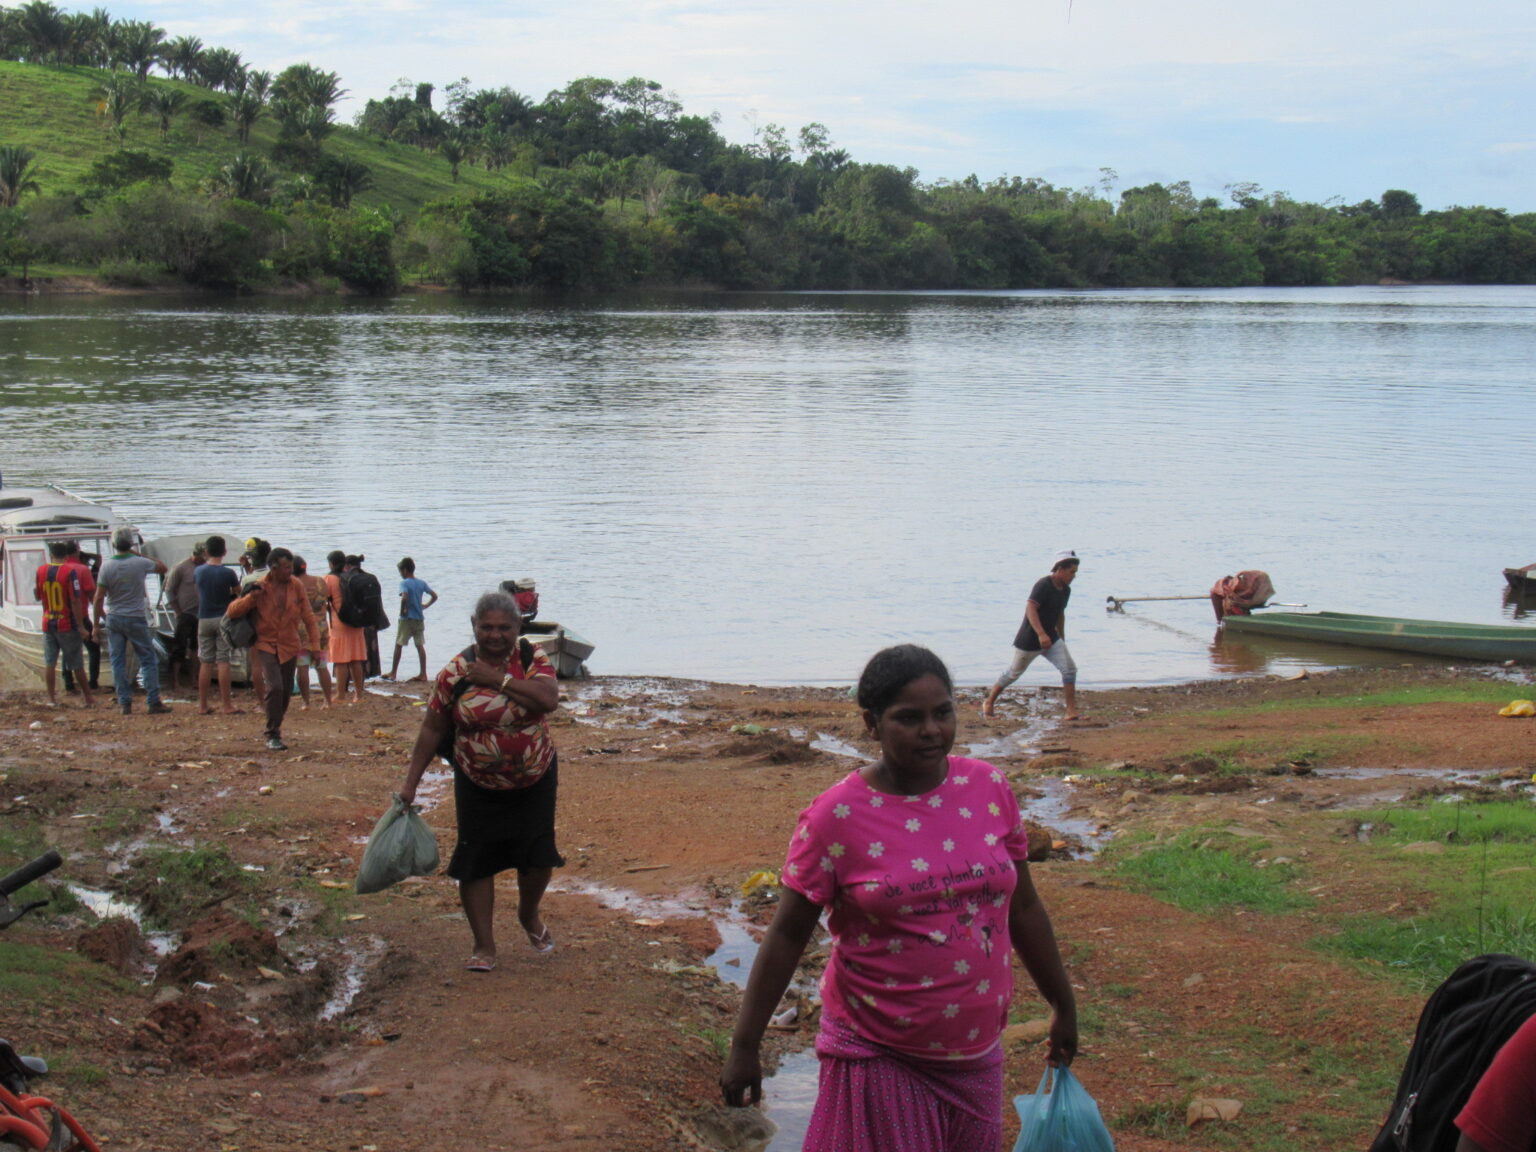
0, 487, 132, 685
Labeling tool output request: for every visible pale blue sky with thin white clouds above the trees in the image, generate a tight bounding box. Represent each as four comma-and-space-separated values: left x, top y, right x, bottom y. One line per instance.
108, 0, 1536, 212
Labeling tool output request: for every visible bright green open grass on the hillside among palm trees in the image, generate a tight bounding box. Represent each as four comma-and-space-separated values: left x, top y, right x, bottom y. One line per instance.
0, 60, 511, 215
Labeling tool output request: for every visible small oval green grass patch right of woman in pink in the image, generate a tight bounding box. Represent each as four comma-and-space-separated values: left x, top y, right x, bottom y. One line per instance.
1104, 829, 1310, 912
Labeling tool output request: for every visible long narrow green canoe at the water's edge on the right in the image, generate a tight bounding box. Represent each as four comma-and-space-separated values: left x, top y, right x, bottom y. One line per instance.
1221, 611, 1536, 662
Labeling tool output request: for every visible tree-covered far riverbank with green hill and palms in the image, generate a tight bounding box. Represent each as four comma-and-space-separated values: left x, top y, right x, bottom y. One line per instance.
0, 0, 1536, 292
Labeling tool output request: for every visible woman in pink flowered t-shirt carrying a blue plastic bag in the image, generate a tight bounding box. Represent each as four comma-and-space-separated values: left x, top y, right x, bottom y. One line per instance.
720, 644, 1077, 1152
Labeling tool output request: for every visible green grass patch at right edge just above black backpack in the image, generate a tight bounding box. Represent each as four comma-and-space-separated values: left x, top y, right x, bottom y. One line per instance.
1321, 799, 1536, 988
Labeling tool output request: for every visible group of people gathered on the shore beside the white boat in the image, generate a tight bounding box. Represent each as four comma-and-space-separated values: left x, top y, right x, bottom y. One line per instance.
35, 527, 438, 751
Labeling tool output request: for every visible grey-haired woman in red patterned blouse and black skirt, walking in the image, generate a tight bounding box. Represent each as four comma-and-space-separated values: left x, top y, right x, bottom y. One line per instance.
399, 591, 565, 972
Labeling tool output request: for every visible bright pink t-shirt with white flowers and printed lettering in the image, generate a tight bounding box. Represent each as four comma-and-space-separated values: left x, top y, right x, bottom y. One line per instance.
783, 756, 1029, 1058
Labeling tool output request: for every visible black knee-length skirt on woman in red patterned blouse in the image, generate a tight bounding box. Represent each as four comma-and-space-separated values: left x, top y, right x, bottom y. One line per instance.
449, 756, 565, 880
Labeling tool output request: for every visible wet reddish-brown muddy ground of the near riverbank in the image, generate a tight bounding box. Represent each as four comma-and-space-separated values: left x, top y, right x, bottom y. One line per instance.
0, 657, 1536, 1152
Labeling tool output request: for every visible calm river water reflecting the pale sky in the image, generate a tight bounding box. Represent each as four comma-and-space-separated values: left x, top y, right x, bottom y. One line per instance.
0, 287, 1536, 687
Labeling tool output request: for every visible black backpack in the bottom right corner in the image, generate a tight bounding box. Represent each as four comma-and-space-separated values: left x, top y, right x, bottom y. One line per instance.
1370, 954, 1536, 1152
